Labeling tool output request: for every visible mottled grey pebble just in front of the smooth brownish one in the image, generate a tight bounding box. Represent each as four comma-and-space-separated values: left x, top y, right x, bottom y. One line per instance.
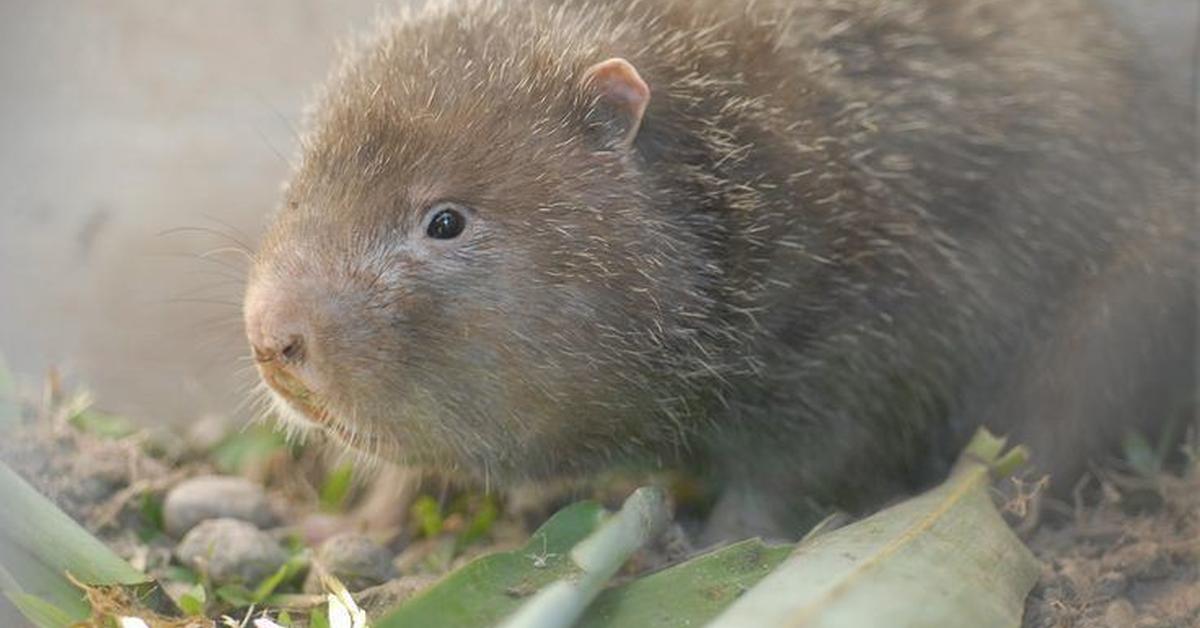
175, 519, 288, 586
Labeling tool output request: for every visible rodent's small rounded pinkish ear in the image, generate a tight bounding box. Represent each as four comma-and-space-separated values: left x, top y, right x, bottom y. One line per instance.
581, 58, 650, 150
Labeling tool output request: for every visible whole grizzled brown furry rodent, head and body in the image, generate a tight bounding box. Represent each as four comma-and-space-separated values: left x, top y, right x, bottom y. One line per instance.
247, 0, 1194, 535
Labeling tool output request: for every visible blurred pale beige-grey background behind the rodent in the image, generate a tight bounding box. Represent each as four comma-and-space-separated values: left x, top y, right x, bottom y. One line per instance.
0, 0, 1200, 423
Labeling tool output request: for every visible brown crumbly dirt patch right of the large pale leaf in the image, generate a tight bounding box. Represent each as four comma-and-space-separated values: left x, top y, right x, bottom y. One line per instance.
1025, 465, 1200, 628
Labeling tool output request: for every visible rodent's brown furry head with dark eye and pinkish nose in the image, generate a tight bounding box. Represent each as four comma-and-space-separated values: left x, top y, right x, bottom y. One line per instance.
245, 6, 708, 480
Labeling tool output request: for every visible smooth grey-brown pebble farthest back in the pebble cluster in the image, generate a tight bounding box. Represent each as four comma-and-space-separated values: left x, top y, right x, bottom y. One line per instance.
162, 476, 276, 538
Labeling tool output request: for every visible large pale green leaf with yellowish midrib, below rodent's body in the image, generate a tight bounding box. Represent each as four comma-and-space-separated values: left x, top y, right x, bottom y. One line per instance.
712, 432, 1039, 628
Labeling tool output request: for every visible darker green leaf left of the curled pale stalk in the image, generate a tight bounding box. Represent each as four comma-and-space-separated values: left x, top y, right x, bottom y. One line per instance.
373, 502, 605, 628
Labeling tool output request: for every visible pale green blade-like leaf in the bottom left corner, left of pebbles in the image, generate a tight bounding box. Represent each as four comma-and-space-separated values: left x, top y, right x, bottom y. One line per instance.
0, 463, 164, 626
